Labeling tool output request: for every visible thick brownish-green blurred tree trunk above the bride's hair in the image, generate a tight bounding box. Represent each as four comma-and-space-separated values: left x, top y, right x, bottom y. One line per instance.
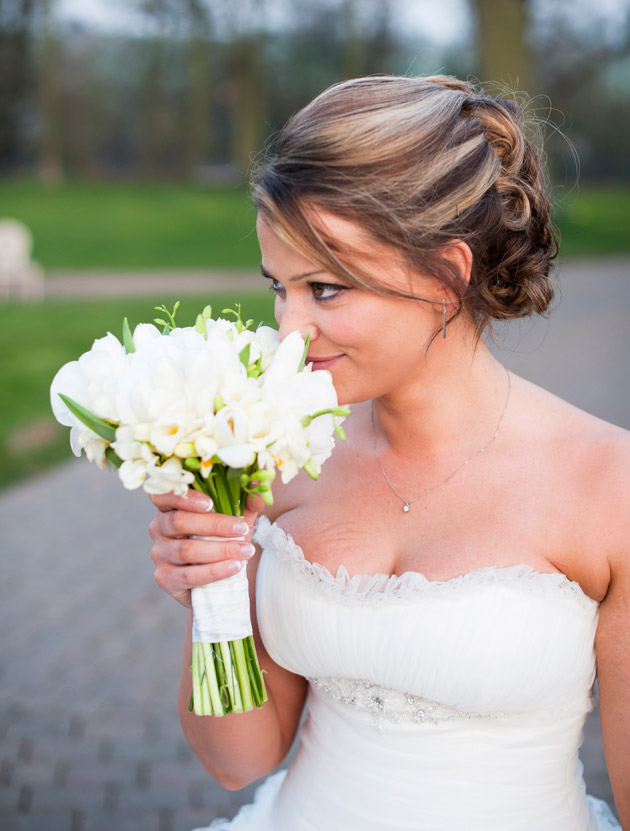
472, 0, 534, 94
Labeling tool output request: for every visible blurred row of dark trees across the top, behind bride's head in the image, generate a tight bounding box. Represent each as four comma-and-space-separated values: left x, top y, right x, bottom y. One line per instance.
0, 0, 630, 182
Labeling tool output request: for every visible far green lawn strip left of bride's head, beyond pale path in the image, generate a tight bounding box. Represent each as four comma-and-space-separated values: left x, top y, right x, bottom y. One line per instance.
0, 181, 260, 270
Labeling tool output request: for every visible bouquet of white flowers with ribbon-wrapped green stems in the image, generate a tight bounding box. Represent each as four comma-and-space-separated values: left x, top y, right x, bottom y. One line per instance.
50, 303, 349, 716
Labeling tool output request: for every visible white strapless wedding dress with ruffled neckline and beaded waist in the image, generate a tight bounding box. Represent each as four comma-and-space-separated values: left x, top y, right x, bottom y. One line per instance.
199, 518, 620, 831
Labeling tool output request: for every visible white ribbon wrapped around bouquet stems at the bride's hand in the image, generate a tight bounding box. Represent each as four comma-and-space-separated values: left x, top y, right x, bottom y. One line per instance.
192, 537, 253, 643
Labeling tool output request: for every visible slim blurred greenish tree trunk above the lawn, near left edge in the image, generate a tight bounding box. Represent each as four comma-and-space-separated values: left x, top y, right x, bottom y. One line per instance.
39, 0, 63, 184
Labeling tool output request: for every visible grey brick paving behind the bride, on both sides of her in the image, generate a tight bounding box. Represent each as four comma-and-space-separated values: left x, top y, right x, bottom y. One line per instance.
0, 261, 630, 831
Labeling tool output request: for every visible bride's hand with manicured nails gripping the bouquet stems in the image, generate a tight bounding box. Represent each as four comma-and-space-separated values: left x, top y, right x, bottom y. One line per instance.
149, 490, 257, 607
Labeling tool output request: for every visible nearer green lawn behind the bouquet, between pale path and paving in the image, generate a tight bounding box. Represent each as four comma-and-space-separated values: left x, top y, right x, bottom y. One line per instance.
0, 292, 273, 487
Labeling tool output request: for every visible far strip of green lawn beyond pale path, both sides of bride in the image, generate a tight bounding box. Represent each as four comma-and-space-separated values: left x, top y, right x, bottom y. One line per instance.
0, 180, 630, 270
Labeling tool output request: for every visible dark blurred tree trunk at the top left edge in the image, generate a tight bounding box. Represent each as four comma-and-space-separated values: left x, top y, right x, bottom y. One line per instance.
0, 0, 36, 172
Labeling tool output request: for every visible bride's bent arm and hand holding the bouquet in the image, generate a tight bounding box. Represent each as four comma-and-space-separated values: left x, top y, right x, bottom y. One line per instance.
149, 491, 306, 790
